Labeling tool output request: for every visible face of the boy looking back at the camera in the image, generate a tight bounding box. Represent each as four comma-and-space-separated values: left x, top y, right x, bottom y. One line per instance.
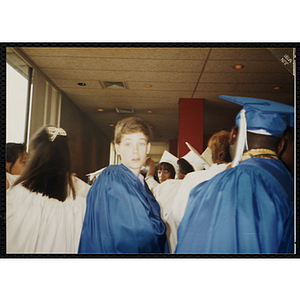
115, 132, 151, 176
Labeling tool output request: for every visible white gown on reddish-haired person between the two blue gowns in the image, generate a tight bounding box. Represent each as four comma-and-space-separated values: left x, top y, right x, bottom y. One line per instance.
164, 164, 228, 253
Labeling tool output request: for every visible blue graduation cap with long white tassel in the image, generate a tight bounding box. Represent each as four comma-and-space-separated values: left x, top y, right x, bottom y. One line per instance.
219, 95, 294, 166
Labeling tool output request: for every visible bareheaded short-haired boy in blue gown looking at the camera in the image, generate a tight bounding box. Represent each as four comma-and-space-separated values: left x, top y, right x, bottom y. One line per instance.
78, 118, 169, 253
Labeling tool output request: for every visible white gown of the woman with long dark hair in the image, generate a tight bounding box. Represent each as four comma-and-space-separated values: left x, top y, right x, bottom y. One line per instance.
6, 177, 90, 254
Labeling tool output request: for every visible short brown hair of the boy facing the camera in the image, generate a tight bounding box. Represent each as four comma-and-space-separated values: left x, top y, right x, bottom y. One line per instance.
114, 117, 152, 144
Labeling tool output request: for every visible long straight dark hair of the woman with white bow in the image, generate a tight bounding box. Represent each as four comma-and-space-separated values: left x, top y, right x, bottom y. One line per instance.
14, 126, 76, 202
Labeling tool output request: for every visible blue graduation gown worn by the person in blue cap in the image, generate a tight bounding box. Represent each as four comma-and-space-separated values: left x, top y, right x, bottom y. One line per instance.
175, 158, 294, 254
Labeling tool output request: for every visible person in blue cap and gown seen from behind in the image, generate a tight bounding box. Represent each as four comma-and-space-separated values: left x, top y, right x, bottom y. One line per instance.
175, 96, 294, 254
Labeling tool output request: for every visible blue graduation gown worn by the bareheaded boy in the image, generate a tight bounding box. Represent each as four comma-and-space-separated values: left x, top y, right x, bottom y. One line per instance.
78, 164, 168, 253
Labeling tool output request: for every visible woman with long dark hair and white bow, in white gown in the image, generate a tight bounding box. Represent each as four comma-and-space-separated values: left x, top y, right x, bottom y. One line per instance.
6, 126, 89, 253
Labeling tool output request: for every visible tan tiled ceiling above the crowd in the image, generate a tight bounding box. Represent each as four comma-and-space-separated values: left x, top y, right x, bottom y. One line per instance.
18, 44, 294, 143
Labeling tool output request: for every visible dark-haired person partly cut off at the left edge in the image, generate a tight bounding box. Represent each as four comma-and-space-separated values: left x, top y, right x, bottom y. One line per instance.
6, 143, 28, 189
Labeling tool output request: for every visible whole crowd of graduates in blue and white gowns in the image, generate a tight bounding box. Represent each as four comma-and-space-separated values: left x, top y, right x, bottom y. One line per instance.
6, 96, 294, 254
